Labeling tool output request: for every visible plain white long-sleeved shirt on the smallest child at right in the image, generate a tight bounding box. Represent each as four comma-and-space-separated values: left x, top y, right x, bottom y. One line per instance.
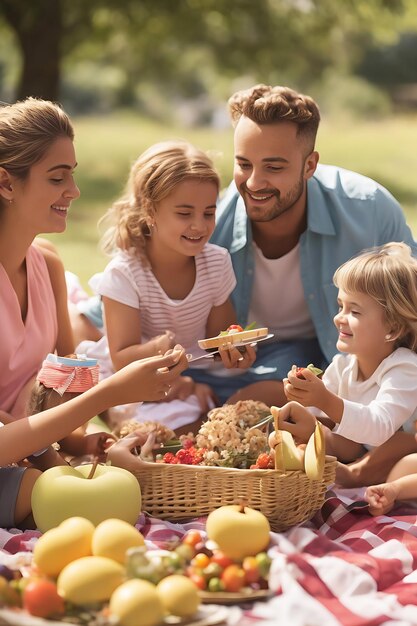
323, 348, 417, 446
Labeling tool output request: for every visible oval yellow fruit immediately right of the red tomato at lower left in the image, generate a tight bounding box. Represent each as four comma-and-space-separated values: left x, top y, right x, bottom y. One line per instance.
57, 556, 125, 606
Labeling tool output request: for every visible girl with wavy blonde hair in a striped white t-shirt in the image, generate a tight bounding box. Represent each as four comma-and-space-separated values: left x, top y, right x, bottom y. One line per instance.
96, 141, 255, 432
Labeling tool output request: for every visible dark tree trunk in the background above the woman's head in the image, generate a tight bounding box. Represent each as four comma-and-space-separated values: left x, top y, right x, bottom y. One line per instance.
2, 0, 63, 101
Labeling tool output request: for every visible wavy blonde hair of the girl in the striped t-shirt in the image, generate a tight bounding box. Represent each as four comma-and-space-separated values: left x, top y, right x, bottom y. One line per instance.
99, 141, 220, 254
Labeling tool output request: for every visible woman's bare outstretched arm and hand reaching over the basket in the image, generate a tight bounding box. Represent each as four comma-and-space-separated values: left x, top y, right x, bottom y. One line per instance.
0, 346, 188, 465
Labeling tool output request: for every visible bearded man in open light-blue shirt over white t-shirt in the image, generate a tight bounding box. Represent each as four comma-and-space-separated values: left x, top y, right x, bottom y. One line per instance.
187, 85, 417, 404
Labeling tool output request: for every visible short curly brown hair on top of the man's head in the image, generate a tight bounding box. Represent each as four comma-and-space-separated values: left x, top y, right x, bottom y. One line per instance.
228, 85, 320, 150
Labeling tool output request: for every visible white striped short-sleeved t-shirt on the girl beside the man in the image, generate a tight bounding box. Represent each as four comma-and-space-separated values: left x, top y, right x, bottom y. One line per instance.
96, 244, 236, 355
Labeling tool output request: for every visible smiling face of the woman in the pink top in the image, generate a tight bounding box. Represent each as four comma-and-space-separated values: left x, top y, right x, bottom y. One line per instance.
10, 137, 80, 235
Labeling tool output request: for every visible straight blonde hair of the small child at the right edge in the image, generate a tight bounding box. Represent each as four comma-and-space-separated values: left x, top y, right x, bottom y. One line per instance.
333, 242, 417, 352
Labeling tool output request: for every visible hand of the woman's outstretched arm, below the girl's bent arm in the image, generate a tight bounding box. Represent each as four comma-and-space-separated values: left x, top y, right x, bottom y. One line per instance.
105, 345, 188, 406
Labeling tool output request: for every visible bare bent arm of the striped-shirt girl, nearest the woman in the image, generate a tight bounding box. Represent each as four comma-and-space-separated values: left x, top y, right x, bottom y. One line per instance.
103, 296, 175, 370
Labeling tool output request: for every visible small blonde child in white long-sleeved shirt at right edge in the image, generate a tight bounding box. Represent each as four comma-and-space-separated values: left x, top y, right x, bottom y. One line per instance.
272, 243, 417, 486
